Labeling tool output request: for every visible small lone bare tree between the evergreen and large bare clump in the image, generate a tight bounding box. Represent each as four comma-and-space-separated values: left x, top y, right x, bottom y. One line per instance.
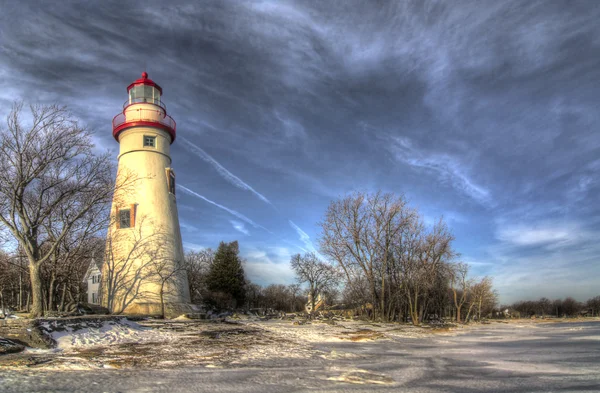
290, 252, 339, 310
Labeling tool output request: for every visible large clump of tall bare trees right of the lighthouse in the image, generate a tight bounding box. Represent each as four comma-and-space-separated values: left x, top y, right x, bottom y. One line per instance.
320, 192, 456, 324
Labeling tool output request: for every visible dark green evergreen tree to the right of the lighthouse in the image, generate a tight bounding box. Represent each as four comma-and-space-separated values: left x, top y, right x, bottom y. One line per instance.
207, 241, 246, 307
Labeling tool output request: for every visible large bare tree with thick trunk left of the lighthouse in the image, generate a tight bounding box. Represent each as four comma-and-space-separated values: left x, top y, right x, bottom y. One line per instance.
0, 104, 114, 317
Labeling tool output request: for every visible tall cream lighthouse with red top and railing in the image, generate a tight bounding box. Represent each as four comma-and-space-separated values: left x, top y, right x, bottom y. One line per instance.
100, 72, 190, 316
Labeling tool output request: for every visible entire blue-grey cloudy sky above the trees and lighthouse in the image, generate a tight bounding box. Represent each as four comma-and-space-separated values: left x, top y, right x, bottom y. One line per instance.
0, 0, 600, 303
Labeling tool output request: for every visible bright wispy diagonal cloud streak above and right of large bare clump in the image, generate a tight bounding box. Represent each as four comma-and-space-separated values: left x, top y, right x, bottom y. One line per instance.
392, 138, 493, 205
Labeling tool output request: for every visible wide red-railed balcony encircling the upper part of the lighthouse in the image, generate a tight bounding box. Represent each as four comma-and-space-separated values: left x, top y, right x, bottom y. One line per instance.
113, 102, 177, 143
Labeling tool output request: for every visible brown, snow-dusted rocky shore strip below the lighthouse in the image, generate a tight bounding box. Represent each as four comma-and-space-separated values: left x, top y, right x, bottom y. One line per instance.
0, 316, 450, 370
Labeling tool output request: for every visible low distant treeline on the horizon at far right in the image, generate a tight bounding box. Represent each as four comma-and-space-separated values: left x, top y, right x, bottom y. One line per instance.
504, 296, 600, 318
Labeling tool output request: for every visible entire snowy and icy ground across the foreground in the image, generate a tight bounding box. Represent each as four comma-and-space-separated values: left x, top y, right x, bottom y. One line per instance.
0, 320, 600, 393
